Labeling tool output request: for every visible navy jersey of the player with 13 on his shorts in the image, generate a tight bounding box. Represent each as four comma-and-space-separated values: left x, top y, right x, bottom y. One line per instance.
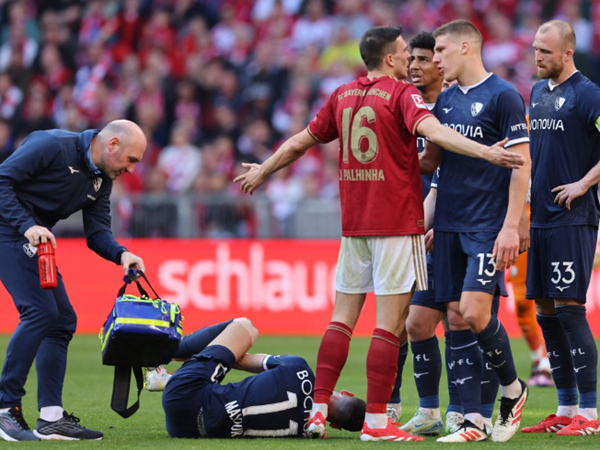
433, 74, 529, 232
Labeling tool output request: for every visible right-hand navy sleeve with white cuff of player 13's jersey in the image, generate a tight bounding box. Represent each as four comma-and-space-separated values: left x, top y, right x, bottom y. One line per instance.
497, 89, 529, 147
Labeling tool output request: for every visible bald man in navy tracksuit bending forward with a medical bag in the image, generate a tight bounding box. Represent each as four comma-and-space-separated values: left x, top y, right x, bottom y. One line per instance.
0, 120, 146, 441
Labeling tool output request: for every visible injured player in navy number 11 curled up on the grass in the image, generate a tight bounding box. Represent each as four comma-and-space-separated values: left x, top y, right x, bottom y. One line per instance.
144, 318, 366, 438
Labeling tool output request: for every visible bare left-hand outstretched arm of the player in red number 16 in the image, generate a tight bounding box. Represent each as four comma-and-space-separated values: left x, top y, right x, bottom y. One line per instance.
233, 129, 319, 195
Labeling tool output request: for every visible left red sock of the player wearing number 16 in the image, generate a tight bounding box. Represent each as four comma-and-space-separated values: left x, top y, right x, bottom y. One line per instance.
314, 322, 354, 403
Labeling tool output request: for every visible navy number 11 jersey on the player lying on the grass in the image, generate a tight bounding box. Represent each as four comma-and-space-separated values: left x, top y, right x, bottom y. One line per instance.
202, 355, 314, 438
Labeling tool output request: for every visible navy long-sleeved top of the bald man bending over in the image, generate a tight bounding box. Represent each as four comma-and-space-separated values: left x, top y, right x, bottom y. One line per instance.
0, 130, 125, 264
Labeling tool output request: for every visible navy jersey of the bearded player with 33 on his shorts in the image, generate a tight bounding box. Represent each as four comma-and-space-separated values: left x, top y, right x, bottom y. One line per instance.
529, 72, 600, 228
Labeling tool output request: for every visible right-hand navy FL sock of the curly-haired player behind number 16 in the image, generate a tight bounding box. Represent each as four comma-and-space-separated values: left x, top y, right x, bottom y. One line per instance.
410, 336, 442, 408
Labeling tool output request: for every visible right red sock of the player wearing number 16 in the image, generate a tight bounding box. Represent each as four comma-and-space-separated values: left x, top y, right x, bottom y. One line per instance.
367, 328, 400, 414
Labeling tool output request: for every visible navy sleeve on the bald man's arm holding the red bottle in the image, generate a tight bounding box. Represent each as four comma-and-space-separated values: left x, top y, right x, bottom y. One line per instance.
0, 131, 61, 234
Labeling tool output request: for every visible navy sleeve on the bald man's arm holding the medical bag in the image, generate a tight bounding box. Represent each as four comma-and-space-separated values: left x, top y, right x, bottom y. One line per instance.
83, 180, 127, 264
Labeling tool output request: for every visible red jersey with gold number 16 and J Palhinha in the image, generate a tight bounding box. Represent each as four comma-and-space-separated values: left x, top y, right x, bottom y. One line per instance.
308, 76, 433, 236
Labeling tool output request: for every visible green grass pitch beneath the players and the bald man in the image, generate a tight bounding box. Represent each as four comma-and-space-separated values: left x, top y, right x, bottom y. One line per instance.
0, 335, 600, 450
